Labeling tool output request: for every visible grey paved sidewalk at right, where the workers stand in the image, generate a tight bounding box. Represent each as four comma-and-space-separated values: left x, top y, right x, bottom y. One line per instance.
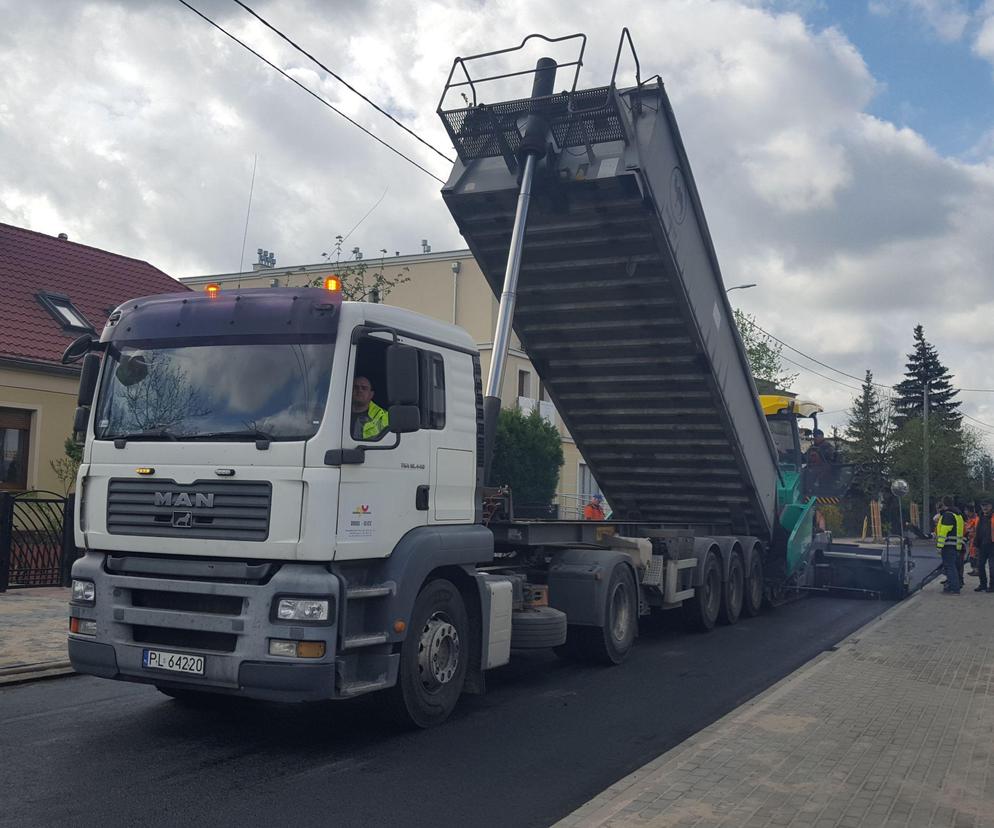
555, 579, 994, 828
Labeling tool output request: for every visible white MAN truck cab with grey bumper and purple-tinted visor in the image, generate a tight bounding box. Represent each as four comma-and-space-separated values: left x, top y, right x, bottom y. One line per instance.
69, 288, 500, 724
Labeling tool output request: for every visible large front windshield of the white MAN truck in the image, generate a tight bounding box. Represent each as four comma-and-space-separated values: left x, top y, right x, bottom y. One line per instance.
96, 342, 334, 440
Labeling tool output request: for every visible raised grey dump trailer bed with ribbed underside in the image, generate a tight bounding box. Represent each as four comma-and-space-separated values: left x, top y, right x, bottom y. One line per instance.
441, 83, 777, 538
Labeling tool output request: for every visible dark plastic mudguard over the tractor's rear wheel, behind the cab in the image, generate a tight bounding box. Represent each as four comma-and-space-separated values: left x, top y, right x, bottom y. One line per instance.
548, 549, 639, 627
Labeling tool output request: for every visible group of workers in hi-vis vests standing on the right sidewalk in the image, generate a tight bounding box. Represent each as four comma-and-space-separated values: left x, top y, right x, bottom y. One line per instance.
932, 496, 994, 595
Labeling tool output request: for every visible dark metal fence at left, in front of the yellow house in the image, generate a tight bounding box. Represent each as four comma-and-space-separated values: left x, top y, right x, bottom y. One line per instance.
0, 491, 77, 592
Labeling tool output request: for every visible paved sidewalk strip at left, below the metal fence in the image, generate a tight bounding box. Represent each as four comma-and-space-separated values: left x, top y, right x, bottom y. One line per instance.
0, 587, 73, 685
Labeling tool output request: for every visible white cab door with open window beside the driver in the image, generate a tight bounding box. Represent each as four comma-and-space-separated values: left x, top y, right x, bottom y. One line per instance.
335, 334, 431, 560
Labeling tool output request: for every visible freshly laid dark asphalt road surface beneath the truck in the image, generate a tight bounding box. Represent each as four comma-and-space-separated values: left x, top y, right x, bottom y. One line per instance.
0, 559, 934, 828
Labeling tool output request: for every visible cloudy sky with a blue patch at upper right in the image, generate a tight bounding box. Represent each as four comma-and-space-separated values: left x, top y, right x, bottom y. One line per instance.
0, 0, 994, 446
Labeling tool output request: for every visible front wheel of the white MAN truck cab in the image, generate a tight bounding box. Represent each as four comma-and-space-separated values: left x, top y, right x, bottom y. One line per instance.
390, 579, 470, 727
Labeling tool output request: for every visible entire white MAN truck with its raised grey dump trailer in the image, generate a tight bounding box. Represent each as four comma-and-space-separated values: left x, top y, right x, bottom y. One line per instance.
65, 31, 836, 727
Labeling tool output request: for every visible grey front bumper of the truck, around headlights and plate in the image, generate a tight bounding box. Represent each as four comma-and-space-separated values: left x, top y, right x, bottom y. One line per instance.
69, 551, 340, 701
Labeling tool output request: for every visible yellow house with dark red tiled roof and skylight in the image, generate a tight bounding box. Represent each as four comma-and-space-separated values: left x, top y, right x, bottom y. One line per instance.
0, 224, 188, 493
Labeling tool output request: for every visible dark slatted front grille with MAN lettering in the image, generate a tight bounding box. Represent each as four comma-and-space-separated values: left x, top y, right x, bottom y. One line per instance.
107, 478, 272, 541
